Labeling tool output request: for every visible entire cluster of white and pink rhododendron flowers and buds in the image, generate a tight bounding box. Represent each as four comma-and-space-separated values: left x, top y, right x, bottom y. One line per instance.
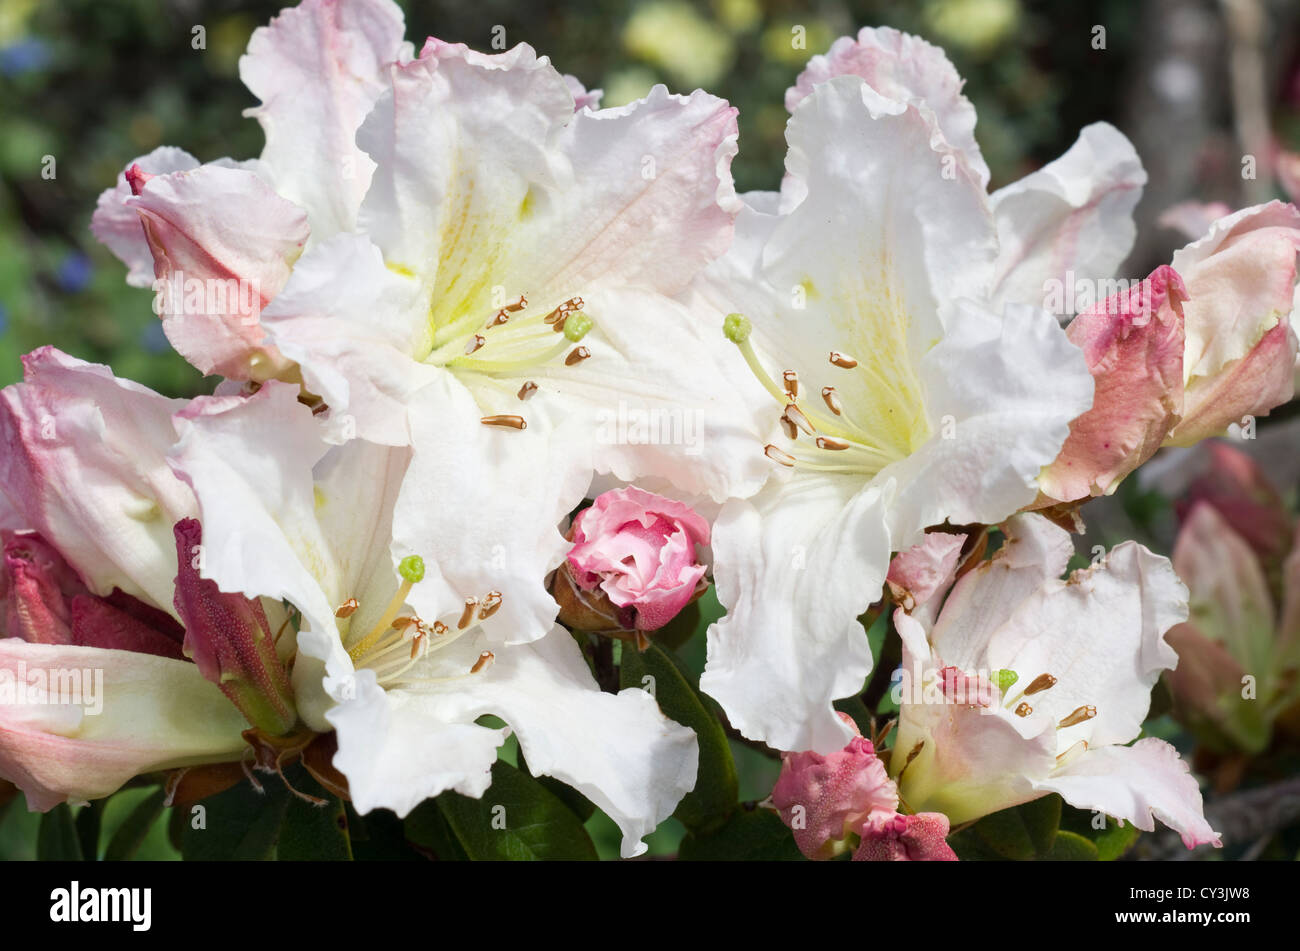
0, 0, 1300, 860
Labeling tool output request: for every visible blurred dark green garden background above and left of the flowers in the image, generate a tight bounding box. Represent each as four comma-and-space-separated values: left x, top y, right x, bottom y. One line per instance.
0, 0, 1289, 396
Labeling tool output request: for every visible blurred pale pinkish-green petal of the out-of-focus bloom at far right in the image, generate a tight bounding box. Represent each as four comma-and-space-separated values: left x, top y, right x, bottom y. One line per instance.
1174, 503, 1282, 696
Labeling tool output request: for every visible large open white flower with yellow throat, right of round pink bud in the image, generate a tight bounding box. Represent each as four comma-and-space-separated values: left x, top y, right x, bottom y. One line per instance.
692, 30, 1144, 752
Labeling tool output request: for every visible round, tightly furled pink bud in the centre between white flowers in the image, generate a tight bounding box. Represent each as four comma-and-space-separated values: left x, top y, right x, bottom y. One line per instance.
556, 486, 710, 631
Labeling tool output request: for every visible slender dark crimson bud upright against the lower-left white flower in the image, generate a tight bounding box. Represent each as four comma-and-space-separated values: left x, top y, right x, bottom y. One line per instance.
173, 518, 298, 735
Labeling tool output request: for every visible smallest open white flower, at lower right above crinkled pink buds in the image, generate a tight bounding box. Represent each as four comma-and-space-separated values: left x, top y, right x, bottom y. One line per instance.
889, 514, 1218, 848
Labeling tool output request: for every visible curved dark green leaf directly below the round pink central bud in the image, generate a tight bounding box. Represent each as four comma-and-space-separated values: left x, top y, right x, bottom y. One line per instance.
619, 644, 740, 831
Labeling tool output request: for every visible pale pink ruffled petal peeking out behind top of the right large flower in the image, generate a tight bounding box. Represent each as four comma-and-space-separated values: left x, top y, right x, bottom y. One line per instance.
785, 27, 989, 187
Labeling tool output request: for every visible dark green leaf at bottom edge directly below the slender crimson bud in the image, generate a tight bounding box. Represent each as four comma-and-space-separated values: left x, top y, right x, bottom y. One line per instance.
181, 776, 290, 861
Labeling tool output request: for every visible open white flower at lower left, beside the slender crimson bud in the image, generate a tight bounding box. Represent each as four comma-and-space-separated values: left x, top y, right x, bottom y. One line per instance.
173, 382, 698, 856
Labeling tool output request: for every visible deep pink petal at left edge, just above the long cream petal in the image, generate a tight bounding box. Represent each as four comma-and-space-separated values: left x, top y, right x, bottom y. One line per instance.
0, 531, 86, 644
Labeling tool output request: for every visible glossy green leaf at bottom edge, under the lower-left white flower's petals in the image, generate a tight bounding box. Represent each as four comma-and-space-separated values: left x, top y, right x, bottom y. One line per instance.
437, 760, 597, 861
